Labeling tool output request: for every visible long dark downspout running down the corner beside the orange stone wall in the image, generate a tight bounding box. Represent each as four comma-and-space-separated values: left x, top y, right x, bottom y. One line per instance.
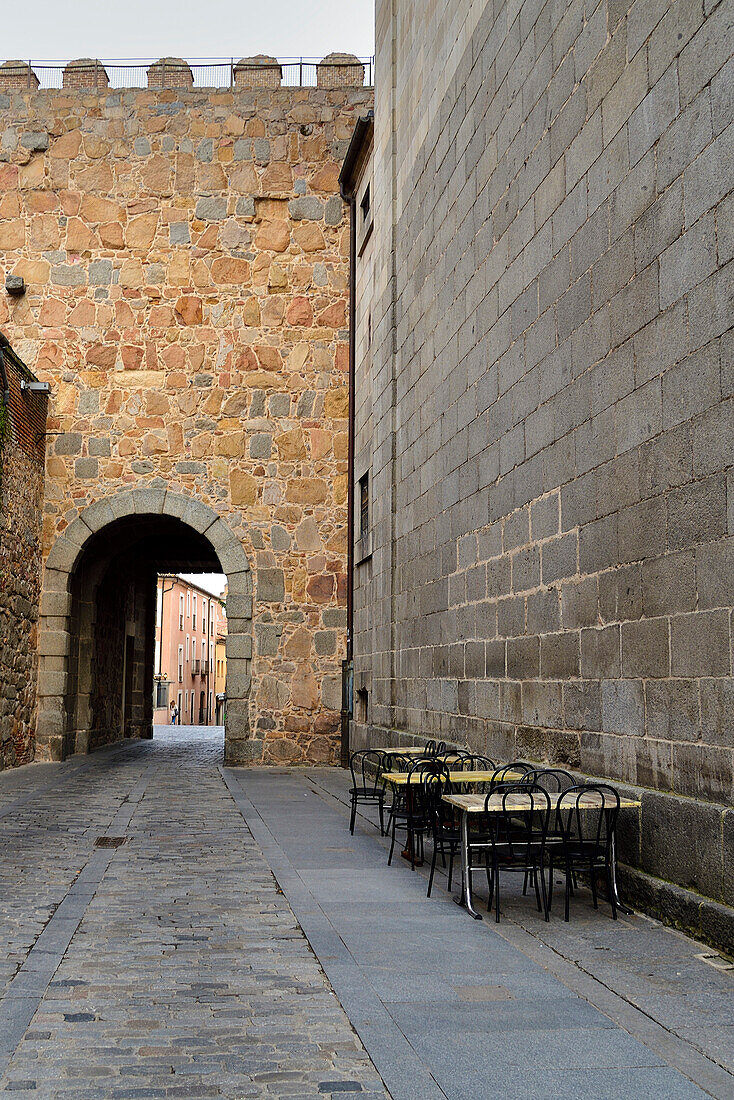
340, 173, 357, 768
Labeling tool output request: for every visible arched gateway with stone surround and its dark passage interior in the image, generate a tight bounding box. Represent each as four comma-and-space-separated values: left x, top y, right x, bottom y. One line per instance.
36, 488, 252, 763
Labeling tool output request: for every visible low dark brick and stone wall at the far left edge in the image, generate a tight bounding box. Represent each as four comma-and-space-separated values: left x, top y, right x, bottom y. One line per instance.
0, 355, 46, 771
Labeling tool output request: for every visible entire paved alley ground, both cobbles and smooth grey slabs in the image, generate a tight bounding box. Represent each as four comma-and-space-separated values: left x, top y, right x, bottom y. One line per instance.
0, 727, 734, 1100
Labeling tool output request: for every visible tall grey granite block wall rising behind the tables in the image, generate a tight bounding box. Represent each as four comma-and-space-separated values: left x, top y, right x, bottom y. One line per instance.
354, 0, 734, 937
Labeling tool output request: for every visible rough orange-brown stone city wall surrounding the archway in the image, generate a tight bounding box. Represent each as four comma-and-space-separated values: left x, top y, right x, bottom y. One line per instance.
0, 77, 372, 762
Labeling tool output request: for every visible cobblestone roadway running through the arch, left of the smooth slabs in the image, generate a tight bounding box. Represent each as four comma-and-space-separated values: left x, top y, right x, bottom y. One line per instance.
0, 726, 387, 1100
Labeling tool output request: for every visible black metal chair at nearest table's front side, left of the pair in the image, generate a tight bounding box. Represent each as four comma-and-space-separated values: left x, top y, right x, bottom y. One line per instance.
484, 782, 550, 924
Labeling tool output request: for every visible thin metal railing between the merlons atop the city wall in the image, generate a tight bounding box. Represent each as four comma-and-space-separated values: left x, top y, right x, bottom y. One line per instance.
0, 57, 374, 90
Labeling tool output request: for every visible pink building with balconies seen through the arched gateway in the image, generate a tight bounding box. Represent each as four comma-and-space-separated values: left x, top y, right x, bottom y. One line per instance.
153, 574, 227, 726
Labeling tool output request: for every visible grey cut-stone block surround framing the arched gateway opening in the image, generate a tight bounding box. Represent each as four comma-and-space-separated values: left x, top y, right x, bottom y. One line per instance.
36, 488, 259, 763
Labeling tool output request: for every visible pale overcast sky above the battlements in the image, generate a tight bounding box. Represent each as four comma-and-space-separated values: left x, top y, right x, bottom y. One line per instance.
0, 0, 374, 61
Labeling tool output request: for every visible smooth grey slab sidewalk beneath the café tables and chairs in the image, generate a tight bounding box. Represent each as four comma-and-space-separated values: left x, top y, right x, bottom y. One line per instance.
231, 769, 734, 1100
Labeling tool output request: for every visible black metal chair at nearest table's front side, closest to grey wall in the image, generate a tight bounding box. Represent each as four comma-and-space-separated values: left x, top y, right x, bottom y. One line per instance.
556, 783, 620, 921
